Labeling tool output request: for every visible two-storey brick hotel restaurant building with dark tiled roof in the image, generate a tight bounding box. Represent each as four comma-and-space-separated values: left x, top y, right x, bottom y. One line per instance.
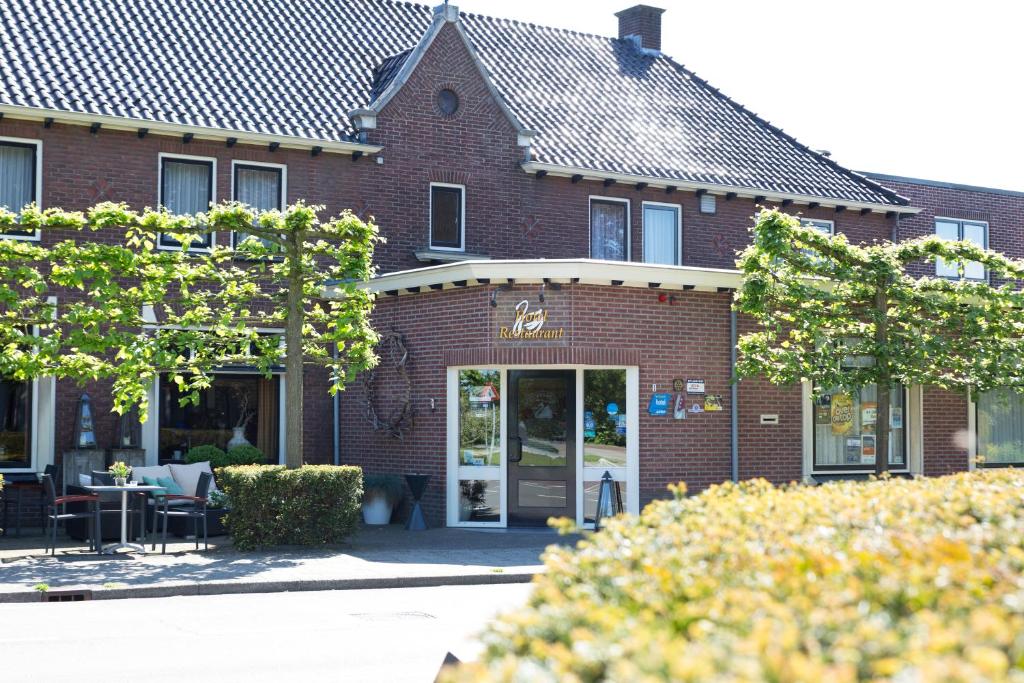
0, 0, 1024, 526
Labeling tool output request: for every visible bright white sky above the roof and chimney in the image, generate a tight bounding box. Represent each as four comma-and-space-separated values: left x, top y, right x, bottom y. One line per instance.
452, 0, 1024, 191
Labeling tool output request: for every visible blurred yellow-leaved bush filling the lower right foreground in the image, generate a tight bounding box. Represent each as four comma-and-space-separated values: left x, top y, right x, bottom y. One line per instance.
450, 470, 1024, 683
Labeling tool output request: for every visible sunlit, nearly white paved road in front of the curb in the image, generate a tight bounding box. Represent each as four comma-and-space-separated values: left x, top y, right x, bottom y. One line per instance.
0, 584, 530, 683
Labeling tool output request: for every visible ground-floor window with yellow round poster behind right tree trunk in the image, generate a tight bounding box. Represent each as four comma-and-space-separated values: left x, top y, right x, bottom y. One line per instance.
813, 385, 907, 471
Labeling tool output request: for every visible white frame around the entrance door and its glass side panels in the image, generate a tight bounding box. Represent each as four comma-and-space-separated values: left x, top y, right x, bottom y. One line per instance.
445, 365, 640, 528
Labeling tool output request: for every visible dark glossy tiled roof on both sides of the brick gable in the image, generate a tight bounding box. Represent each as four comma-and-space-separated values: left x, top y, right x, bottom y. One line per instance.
0, 0, 905, 205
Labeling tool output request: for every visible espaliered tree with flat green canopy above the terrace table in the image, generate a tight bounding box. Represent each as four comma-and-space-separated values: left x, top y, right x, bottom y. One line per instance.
0, 202, 379, 467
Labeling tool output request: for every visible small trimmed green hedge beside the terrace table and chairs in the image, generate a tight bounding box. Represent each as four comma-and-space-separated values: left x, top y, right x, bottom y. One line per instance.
217, 465, 362, 550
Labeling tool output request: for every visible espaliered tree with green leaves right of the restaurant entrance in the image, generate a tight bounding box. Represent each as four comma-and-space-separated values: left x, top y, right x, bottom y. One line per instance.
734, 210, 1024, 473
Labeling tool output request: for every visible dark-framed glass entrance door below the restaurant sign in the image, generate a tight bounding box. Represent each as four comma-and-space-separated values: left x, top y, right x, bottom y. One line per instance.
507, 371, 577, 526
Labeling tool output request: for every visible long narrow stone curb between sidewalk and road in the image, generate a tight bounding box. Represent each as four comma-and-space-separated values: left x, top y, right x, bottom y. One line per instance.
0, 571, 537, 604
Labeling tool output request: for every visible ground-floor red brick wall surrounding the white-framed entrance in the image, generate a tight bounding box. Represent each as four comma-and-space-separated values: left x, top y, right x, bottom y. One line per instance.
342, 285, 801, 523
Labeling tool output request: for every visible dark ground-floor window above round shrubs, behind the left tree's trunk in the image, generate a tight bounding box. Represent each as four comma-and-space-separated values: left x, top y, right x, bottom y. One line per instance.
159, 374, 280, 464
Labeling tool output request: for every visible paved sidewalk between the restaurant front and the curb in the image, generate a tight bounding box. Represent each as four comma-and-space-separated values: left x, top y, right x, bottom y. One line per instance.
0, 525, 574, 602
